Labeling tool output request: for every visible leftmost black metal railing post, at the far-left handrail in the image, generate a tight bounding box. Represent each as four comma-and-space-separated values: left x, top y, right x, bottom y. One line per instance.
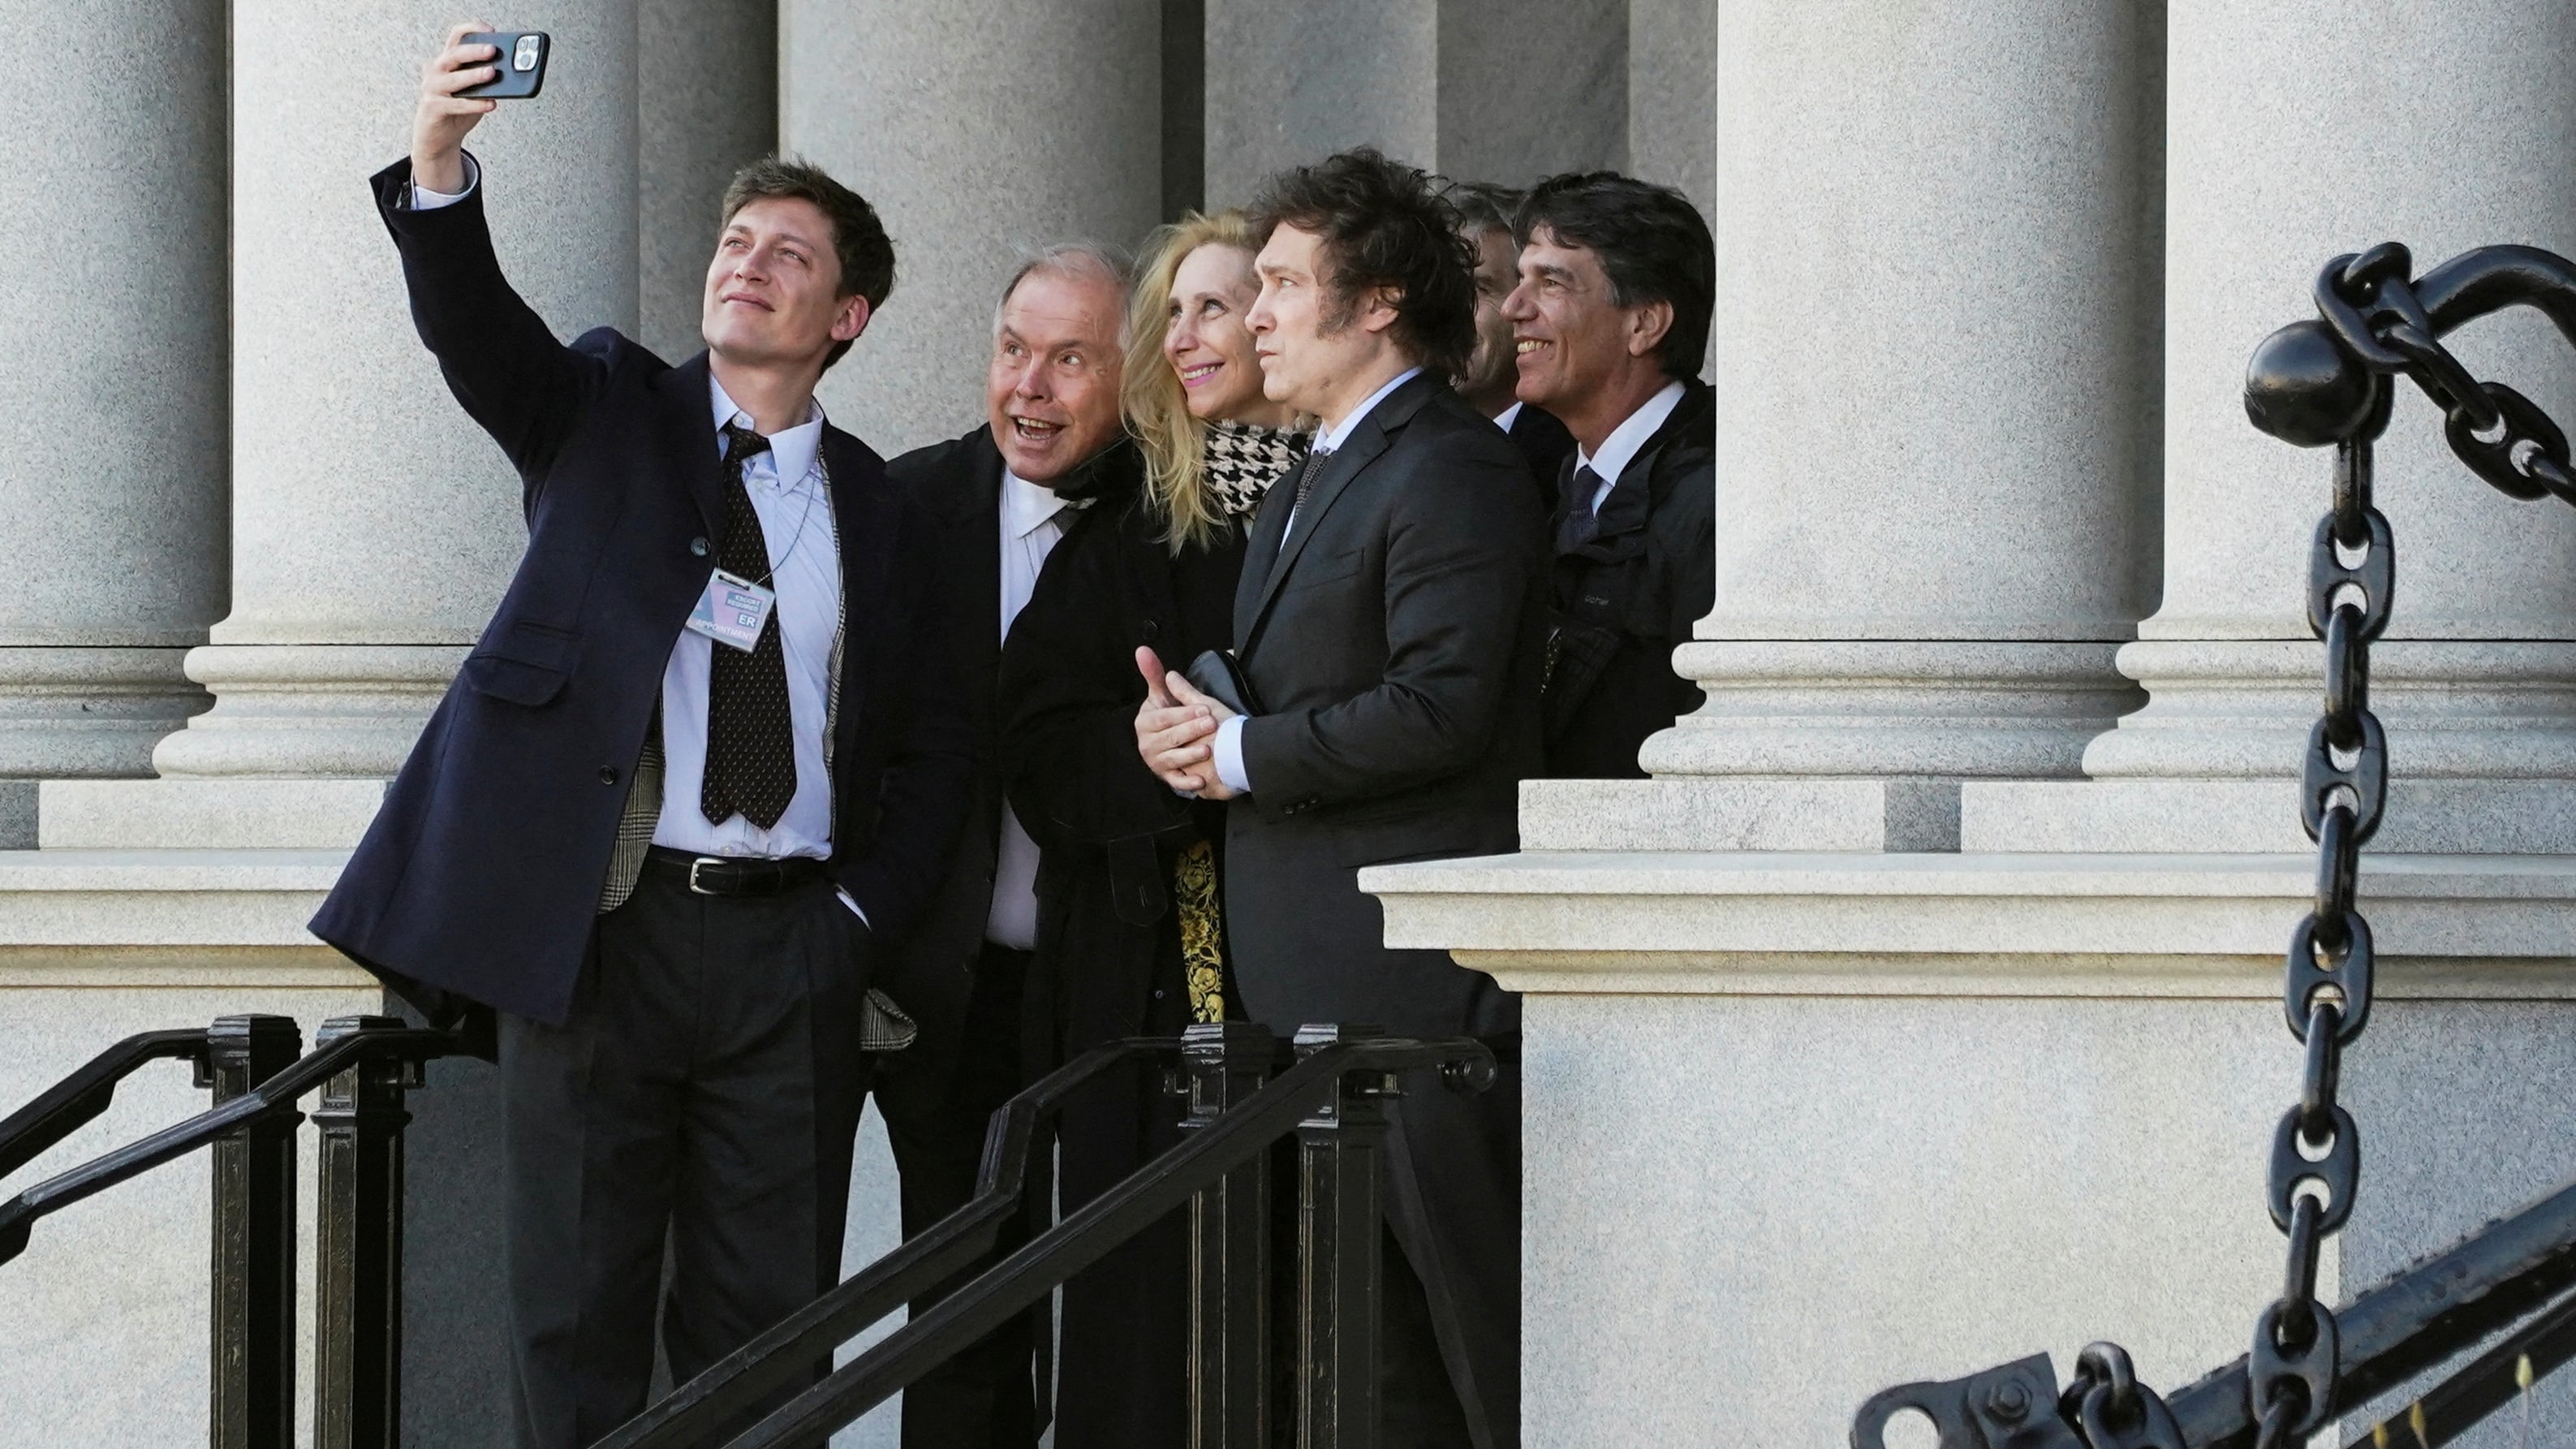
198, 1016, 304, 1449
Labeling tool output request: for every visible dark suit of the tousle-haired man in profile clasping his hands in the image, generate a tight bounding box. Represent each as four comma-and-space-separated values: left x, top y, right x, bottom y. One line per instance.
1226, 366, 1545, 1449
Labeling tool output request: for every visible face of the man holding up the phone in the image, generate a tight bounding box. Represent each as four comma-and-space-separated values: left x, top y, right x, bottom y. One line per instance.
698, 196, 868, 369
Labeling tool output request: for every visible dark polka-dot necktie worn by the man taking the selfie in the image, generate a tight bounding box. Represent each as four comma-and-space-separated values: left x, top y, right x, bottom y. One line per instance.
698, 423, 796, 830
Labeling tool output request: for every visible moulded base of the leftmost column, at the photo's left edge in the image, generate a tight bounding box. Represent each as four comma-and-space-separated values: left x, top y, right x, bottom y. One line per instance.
0, 645, 209, 778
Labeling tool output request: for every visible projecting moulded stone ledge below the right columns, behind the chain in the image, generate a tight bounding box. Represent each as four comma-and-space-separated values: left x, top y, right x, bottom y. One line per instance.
1360, 853, 2576, 998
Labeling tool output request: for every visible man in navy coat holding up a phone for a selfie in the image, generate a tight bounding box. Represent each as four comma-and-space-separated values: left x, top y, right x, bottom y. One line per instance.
312, 26, 974, 1449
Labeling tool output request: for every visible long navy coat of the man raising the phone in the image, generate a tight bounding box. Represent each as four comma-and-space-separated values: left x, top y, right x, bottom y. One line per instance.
312, 162, 974, 1021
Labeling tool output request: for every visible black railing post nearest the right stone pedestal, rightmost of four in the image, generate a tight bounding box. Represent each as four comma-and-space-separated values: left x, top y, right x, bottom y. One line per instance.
1296, 1024, 1396, 1449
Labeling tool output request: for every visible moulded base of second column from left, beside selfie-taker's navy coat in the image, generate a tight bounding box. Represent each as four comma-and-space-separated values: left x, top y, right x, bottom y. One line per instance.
152, 645, 466, 778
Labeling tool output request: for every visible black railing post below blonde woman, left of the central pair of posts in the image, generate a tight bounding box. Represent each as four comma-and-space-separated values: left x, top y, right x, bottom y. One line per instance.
1180, 1021, 1277, 1449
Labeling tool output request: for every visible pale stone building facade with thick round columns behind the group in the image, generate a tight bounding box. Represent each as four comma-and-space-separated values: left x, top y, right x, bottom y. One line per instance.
0, 0, 2576, 1447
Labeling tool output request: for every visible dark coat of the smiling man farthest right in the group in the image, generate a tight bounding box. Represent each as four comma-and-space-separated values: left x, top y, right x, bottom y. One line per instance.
1545, 382, 1718, 778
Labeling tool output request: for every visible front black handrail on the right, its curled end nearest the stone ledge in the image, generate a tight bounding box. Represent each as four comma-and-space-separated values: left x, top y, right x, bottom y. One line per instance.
716, 1037, 1494, 1449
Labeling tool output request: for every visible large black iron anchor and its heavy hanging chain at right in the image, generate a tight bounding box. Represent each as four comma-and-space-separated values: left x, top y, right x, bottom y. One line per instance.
1852, 243, 2576, 1449
